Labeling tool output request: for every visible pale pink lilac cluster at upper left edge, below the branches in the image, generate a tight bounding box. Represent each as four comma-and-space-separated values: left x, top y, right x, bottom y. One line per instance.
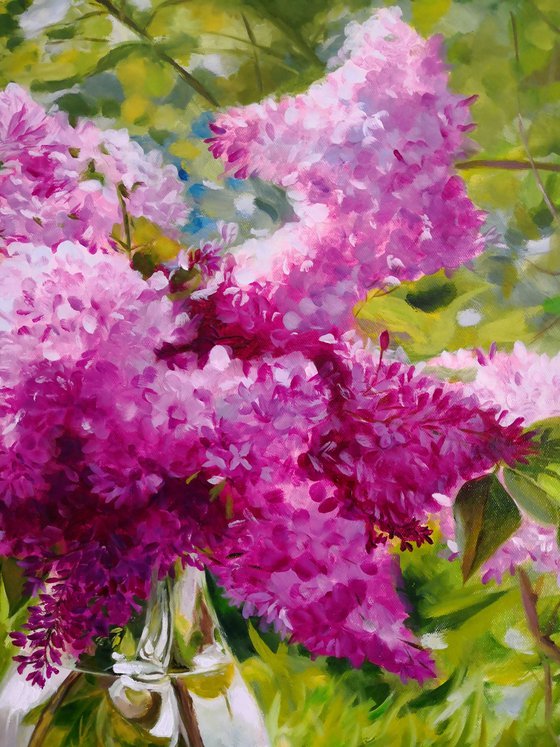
0, 83, 188, 253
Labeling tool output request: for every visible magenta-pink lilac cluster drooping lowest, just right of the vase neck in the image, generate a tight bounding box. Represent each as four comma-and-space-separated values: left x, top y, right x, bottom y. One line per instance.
211, 494, 434, 682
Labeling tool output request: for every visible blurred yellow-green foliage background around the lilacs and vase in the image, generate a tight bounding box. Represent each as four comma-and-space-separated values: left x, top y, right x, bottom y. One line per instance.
0, 0, 560, 747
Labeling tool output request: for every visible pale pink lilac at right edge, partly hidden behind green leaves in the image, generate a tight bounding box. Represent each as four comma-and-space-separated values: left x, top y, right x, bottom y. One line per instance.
429, 342, 560, 583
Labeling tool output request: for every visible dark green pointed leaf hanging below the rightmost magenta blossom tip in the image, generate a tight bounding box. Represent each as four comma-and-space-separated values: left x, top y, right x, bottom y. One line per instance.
454, 475, 521, 581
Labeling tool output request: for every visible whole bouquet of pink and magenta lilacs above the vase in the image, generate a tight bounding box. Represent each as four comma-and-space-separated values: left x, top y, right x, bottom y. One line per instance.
0, 11, 544, 696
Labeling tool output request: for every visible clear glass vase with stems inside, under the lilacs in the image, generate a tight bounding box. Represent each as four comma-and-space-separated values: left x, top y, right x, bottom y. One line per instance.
0, 568, 269, 747
